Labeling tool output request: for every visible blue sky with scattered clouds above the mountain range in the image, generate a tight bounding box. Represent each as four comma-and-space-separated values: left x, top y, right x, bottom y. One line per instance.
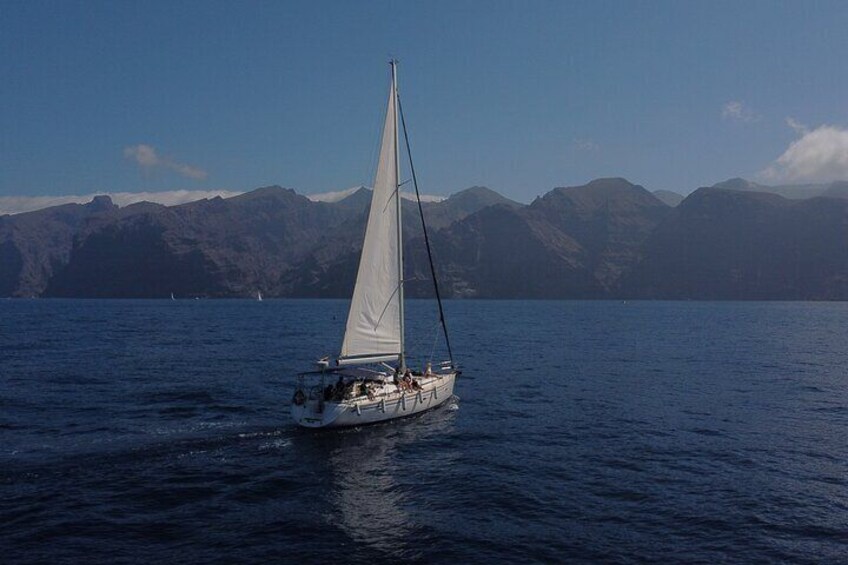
0, 0, 848, 205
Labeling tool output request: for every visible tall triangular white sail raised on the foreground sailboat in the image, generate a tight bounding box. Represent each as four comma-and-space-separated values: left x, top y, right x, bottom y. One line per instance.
341, 82, 401, 358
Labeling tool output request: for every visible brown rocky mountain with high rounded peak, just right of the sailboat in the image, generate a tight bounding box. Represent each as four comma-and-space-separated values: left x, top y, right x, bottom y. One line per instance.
400, 179, 669, 298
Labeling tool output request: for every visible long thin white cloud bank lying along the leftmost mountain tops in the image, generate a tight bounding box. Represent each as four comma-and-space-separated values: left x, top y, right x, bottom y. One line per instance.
0, 190, 242, 215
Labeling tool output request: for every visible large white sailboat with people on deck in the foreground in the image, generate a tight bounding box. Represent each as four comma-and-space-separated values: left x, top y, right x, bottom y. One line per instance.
291, 61, 460, 428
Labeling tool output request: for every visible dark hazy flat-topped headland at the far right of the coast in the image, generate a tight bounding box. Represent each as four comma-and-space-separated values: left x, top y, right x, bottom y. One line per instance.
623, 188, 848, 300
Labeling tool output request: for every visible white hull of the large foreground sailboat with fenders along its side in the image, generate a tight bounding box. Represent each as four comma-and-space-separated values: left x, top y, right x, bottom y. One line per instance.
291, 372, 456, 428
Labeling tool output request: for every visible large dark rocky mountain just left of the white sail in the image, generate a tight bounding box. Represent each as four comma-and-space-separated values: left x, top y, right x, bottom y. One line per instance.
46, 186, 347, 297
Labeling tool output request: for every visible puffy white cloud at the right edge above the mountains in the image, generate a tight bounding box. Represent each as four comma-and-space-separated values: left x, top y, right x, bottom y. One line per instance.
760, 118, 848, 182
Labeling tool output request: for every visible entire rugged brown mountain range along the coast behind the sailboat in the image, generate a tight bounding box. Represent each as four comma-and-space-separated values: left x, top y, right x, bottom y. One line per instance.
0, 178, 848, 300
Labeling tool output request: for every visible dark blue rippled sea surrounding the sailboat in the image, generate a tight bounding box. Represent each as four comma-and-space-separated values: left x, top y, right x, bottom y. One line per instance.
0, 300, 848, 564
